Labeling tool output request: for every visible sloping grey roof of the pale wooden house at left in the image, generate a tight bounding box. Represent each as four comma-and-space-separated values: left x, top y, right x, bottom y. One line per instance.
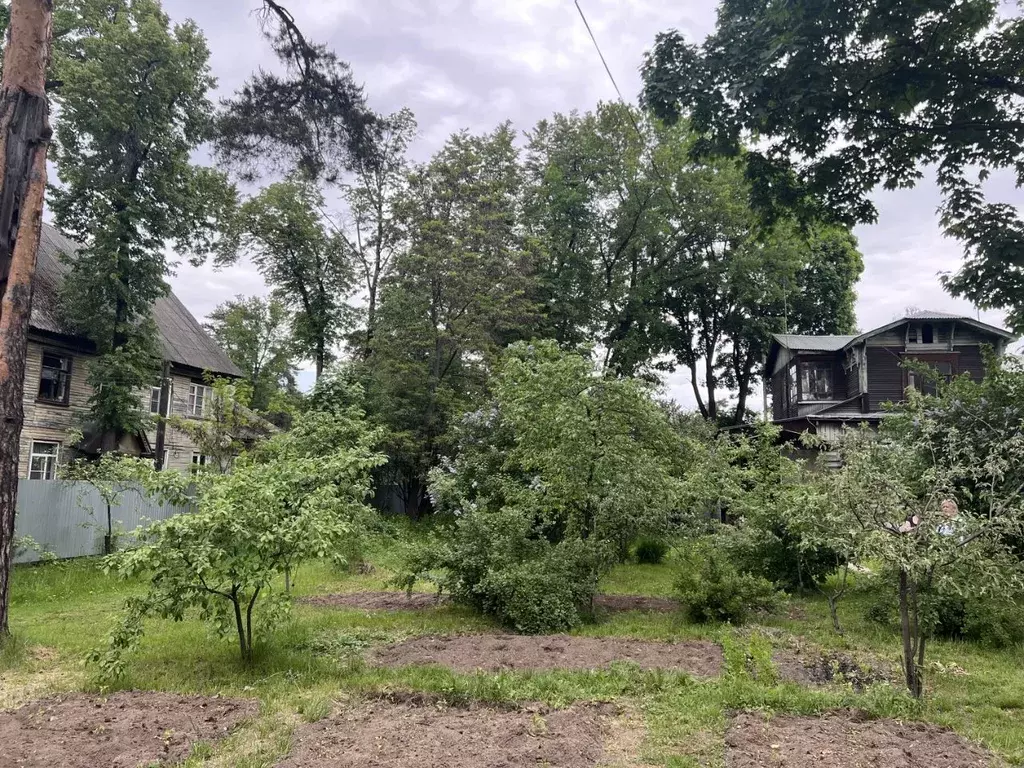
31, 223, 242, 376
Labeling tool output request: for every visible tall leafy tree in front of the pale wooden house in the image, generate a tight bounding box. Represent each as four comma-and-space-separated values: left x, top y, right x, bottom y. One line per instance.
50, 0, 234, 435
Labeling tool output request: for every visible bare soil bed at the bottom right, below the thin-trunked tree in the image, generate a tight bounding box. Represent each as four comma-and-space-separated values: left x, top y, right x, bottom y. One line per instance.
725, 712, 992, 768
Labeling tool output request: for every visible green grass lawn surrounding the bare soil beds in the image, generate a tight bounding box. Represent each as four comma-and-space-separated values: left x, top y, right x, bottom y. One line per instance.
0, 542, 1024, 768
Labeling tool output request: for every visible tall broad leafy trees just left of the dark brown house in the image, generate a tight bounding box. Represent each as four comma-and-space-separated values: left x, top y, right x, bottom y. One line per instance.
524, 104, 863, 423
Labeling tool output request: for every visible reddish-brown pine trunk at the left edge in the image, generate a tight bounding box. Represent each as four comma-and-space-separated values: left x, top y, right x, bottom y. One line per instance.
0, 0, 53, 641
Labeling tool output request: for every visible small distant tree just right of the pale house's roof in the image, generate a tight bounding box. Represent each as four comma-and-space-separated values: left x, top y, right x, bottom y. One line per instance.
206, 296, 295, 413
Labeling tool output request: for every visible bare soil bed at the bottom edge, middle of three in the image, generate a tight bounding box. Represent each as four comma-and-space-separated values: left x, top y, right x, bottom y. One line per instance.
279, 699, 611, 768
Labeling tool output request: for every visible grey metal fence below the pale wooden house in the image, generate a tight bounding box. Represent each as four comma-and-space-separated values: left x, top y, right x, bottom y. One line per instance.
14, 479, 189, 562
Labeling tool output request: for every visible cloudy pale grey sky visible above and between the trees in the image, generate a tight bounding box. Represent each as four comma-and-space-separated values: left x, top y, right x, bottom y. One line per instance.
157, 0, 1021, 404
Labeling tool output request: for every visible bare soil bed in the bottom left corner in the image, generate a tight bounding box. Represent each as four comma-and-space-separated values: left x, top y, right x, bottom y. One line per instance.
0, 691, 257, 768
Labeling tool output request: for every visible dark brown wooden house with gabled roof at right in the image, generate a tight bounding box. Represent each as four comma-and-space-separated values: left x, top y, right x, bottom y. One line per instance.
767, 311, 1014, 440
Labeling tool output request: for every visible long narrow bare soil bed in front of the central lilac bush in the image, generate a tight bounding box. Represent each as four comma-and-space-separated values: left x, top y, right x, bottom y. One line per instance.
373, 635, 722, 677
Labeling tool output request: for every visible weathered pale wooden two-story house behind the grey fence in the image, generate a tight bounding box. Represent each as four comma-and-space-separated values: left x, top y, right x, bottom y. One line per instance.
18, 224, 242, 479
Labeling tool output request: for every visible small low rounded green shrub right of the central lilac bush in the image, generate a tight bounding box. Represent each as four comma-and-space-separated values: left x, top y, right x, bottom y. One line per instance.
676, 547, 783, 624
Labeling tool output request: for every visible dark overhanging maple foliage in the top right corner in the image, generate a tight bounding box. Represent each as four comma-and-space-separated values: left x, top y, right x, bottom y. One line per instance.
644, 0, 1024, 324
